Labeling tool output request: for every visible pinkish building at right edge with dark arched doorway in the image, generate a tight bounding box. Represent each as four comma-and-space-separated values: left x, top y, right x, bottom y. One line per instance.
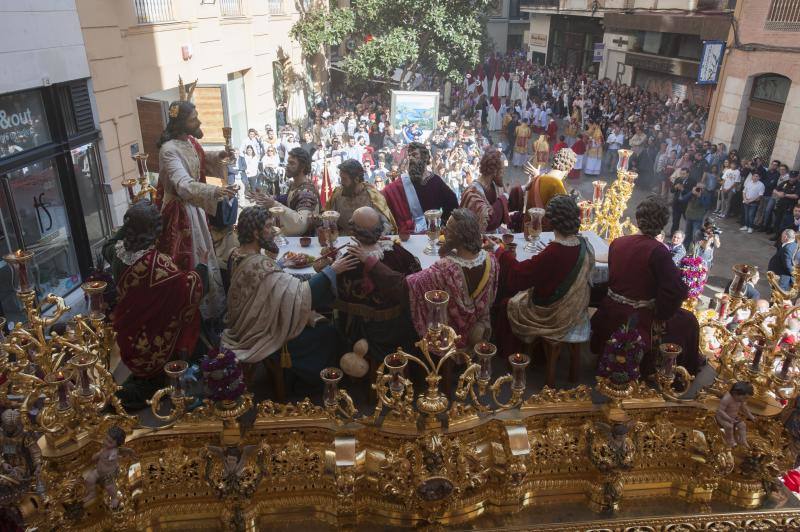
709, 0, 800, 169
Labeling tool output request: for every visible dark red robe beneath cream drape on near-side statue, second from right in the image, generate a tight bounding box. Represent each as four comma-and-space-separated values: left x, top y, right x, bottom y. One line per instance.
492, 243, 580, 356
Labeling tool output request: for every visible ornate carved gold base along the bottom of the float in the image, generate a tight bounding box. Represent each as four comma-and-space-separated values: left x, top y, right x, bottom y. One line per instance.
42, 400, 800, 531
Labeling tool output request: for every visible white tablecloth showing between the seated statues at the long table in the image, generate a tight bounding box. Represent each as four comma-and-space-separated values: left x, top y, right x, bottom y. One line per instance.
278, 231, 608, 283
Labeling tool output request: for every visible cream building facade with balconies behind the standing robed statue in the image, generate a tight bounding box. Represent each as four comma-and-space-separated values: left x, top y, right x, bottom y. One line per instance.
76, 0, 312, 223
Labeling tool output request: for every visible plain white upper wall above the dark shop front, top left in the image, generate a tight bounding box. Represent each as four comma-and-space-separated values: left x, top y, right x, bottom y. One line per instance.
0, 0, 89, 93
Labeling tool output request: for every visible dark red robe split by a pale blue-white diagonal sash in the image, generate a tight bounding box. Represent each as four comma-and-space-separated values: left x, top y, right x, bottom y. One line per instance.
381, 174, 458, 234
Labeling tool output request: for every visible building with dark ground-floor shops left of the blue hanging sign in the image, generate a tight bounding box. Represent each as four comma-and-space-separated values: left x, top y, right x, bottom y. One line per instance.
522, 0, 730, 106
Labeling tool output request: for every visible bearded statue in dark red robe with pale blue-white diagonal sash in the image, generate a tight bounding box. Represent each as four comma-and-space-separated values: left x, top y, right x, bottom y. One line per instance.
383, 142, 458, 234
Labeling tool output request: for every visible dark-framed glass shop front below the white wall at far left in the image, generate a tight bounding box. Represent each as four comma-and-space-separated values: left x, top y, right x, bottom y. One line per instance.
0, 80, 111, 321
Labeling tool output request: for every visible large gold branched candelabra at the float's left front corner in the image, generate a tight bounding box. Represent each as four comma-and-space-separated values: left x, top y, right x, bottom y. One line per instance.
0, 250, 133, 448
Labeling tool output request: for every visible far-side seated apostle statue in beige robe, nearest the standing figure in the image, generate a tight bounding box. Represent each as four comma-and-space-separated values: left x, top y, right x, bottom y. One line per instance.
250, 147, 320, 236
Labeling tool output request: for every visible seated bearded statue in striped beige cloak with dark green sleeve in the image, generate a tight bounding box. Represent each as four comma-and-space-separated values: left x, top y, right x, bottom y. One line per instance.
222, 206, 358, 393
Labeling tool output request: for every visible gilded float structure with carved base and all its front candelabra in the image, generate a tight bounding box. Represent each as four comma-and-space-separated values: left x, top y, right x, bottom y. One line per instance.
0, 152, 800, 531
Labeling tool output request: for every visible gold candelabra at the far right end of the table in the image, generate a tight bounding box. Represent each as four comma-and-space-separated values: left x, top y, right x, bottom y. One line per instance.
588, 149, 639, 242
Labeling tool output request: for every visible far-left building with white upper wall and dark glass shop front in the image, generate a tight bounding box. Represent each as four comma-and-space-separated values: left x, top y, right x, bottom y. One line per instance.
0, 0, 111, 321
